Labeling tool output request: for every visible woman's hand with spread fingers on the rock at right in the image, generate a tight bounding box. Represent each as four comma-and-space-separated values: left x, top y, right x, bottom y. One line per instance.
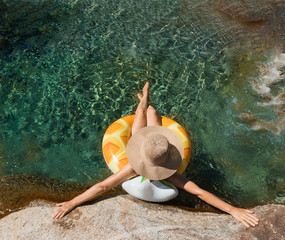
229, 207, 259, 228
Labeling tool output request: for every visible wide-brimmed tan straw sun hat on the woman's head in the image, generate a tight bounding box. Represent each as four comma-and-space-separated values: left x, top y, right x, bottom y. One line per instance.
127, 126, 184, 180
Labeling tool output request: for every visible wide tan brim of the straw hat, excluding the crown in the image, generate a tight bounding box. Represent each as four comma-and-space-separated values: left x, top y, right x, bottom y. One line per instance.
126, 126, 184, 180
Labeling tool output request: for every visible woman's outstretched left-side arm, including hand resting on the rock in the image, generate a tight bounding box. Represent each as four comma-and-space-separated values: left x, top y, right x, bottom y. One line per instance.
52, 164, 136, 219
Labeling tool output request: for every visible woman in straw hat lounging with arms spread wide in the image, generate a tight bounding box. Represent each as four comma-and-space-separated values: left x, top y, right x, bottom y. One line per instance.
53, 83, 259, 227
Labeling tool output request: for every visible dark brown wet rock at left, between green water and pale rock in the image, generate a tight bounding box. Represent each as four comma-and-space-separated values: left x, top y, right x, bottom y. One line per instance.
0, 174, 87, 218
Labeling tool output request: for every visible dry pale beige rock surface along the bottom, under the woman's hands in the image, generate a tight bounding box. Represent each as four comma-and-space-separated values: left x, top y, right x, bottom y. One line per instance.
0, 195, 285, 240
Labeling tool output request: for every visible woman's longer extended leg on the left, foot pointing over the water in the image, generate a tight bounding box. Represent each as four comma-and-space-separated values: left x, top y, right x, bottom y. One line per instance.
132, 82, 149, 135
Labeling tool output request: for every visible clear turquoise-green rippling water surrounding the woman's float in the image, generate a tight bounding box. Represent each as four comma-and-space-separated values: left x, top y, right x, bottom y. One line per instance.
0, 0, 285, 205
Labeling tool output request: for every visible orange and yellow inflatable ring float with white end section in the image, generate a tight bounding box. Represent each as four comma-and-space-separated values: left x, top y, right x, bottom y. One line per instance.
102, 115, 191, 202
